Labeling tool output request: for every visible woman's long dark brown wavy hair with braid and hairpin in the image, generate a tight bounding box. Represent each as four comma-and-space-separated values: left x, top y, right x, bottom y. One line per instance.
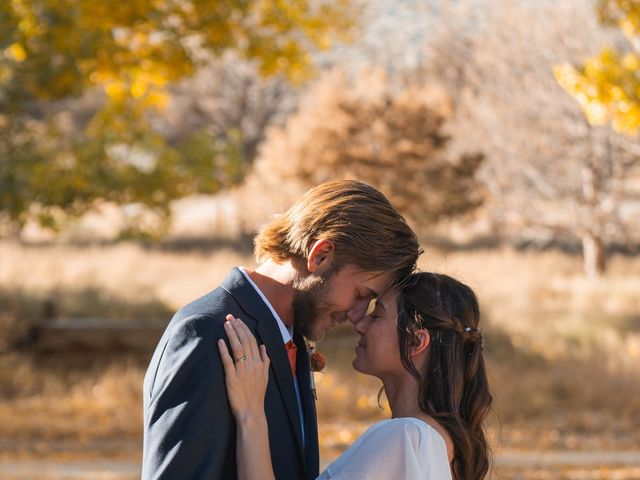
398, 272, 493, 480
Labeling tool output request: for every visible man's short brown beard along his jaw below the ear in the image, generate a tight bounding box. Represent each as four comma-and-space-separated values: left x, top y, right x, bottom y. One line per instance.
292, 268, 334, 340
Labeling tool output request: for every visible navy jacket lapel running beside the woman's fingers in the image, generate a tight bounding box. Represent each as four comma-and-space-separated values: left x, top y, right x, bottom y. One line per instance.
222, 268, 304, 458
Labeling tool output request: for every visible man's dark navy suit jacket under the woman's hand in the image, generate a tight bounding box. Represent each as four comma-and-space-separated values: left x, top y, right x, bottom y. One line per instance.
142, 268, 319, 480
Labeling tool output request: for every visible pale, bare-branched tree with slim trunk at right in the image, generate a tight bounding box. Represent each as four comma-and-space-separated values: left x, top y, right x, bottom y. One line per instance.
419, 0, 640, 276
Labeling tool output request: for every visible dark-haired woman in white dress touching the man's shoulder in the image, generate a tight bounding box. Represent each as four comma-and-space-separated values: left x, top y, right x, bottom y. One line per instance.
218, 273, 492, 480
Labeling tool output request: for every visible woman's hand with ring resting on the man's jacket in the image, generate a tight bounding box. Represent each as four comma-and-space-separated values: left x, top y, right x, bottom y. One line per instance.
218, 315, 270, 423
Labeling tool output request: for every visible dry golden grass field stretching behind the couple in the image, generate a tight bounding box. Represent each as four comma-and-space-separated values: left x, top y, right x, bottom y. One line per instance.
0, 242, 640, 479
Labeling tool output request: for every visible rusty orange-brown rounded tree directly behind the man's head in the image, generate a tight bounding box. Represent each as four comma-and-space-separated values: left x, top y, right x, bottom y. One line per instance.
244, 71, 483, 234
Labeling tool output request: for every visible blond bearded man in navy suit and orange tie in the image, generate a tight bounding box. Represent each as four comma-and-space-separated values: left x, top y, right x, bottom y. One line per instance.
142, 180, 420, 480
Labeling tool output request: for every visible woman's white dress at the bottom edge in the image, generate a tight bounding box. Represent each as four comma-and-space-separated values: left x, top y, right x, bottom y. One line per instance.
318, 417, 451, 480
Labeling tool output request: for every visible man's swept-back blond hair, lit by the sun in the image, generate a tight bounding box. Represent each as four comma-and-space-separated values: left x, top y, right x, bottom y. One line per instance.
254, 180, 422, 279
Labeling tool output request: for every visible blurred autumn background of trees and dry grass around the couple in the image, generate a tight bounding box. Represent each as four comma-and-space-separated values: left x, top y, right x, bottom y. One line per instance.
0, 0, 640, 480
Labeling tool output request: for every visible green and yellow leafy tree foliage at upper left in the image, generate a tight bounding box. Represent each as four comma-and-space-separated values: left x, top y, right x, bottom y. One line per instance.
0, 0, 353, 235
